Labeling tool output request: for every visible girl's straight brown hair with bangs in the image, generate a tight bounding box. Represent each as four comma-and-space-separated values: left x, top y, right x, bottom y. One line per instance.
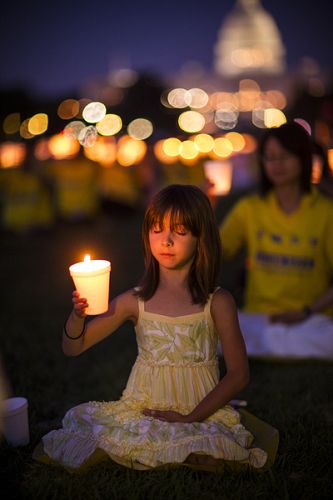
136, 184, 221, 304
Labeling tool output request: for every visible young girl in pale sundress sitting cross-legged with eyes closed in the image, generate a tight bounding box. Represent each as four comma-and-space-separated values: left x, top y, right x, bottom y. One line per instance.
39, 185, 267, 469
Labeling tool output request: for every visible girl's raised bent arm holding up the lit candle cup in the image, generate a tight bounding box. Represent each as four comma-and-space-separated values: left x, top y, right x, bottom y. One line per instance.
62, 290, 138, 356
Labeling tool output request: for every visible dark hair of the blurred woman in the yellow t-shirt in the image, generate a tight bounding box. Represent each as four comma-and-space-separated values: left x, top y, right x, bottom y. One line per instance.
258, 122, 312, 195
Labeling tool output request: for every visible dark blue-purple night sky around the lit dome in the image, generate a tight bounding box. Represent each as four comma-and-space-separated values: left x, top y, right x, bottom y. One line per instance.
0, 0, 333, 95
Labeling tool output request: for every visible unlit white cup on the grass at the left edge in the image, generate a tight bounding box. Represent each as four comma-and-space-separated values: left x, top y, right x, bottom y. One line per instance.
3, 397, 30, 446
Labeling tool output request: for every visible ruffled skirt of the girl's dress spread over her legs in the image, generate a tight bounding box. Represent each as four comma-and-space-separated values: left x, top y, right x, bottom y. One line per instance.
43, 401, 267, 469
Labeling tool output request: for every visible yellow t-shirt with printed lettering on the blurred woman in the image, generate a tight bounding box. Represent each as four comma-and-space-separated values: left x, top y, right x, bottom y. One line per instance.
220, 188, 333, 314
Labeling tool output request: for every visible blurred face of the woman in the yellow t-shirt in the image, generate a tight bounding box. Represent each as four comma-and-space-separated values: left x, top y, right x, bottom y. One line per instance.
263, 137, 301, 187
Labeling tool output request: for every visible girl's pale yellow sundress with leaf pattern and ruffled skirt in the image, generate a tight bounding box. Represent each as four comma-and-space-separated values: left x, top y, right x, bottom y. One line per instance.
42, 295, 267, 469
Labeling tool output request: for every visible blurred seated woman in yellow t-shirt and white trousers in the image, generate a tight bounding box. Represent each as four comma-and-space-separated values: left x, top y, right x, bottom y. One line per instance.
220, 122, 333, 359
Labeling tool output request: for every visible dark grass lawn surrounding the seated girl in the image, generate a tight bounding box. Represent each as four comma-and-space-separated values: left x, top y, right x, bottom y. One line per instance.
0, 201, 333, 500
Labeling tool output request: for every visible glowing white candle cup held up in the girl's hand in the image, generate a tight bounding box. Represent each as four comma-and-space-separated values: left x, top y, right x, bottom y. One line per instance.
69, 260, 111, 315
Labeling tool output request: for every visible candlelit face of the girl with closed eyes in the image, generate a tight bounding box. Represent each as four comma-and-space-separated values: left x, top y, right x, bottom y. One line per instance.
149, 213, 198, 270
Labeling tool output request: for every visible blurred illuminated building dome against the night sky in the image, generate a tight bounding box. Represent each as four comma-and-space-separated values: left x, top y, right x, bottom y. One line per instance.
215, 0, 285, 77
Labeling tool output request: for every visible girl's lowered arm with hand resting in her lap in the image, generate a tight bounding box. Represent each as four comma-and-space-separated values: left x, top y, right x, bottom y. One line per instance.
144, 290, 249, 422
